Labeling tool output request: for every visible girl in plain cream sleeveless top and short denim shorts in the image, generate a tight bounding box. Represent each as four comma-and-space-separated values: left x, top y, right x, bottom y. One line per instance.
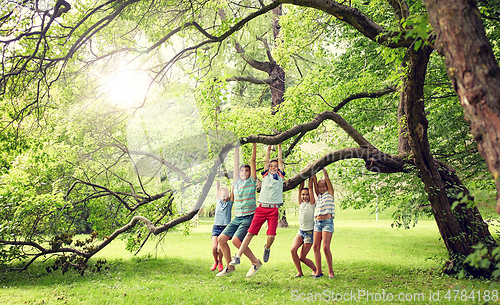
290, 178, 316, 277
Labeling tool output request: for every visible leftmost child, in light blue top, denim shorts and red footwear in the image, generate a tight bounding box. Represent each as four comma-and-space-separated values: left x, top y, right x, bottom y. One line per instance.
211, 181, 233, 272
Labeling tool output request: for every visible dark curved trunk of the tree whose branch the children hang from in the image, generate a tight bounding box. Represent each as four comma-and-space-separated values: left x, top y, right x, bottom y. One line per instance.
401, 46, 495, 276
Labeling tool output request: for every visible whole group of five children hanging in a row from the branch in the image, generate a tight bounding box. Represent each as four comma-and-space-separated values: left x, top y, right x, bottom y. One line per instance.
211, 143, 335, 279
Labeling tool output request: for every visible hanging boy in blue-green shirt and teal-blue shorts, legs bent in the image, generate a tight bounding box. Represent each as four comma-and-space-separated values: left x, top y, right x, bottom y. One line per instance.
217, 143, 262, 276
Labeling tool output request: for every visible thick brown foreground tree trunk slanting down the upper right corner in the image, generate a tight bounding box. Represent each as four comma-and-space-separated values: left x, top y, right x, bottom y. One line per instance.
424, 0, 500, 206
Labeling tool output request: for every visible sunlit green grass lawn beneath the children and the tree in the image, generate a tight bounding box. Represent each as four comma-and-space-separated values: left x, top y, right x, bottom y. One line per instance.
0, 210, 499, 304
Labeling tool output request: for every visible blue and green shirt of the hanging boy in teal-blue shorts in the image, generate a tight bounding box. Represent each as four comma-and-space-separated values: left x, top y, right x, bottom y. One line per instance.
233, 176, 257, 217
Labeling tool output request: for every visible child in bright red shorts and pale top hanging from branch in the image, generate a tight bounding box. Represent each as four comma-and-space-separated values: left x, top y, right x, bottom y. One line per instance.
229, 144, 285, 266
